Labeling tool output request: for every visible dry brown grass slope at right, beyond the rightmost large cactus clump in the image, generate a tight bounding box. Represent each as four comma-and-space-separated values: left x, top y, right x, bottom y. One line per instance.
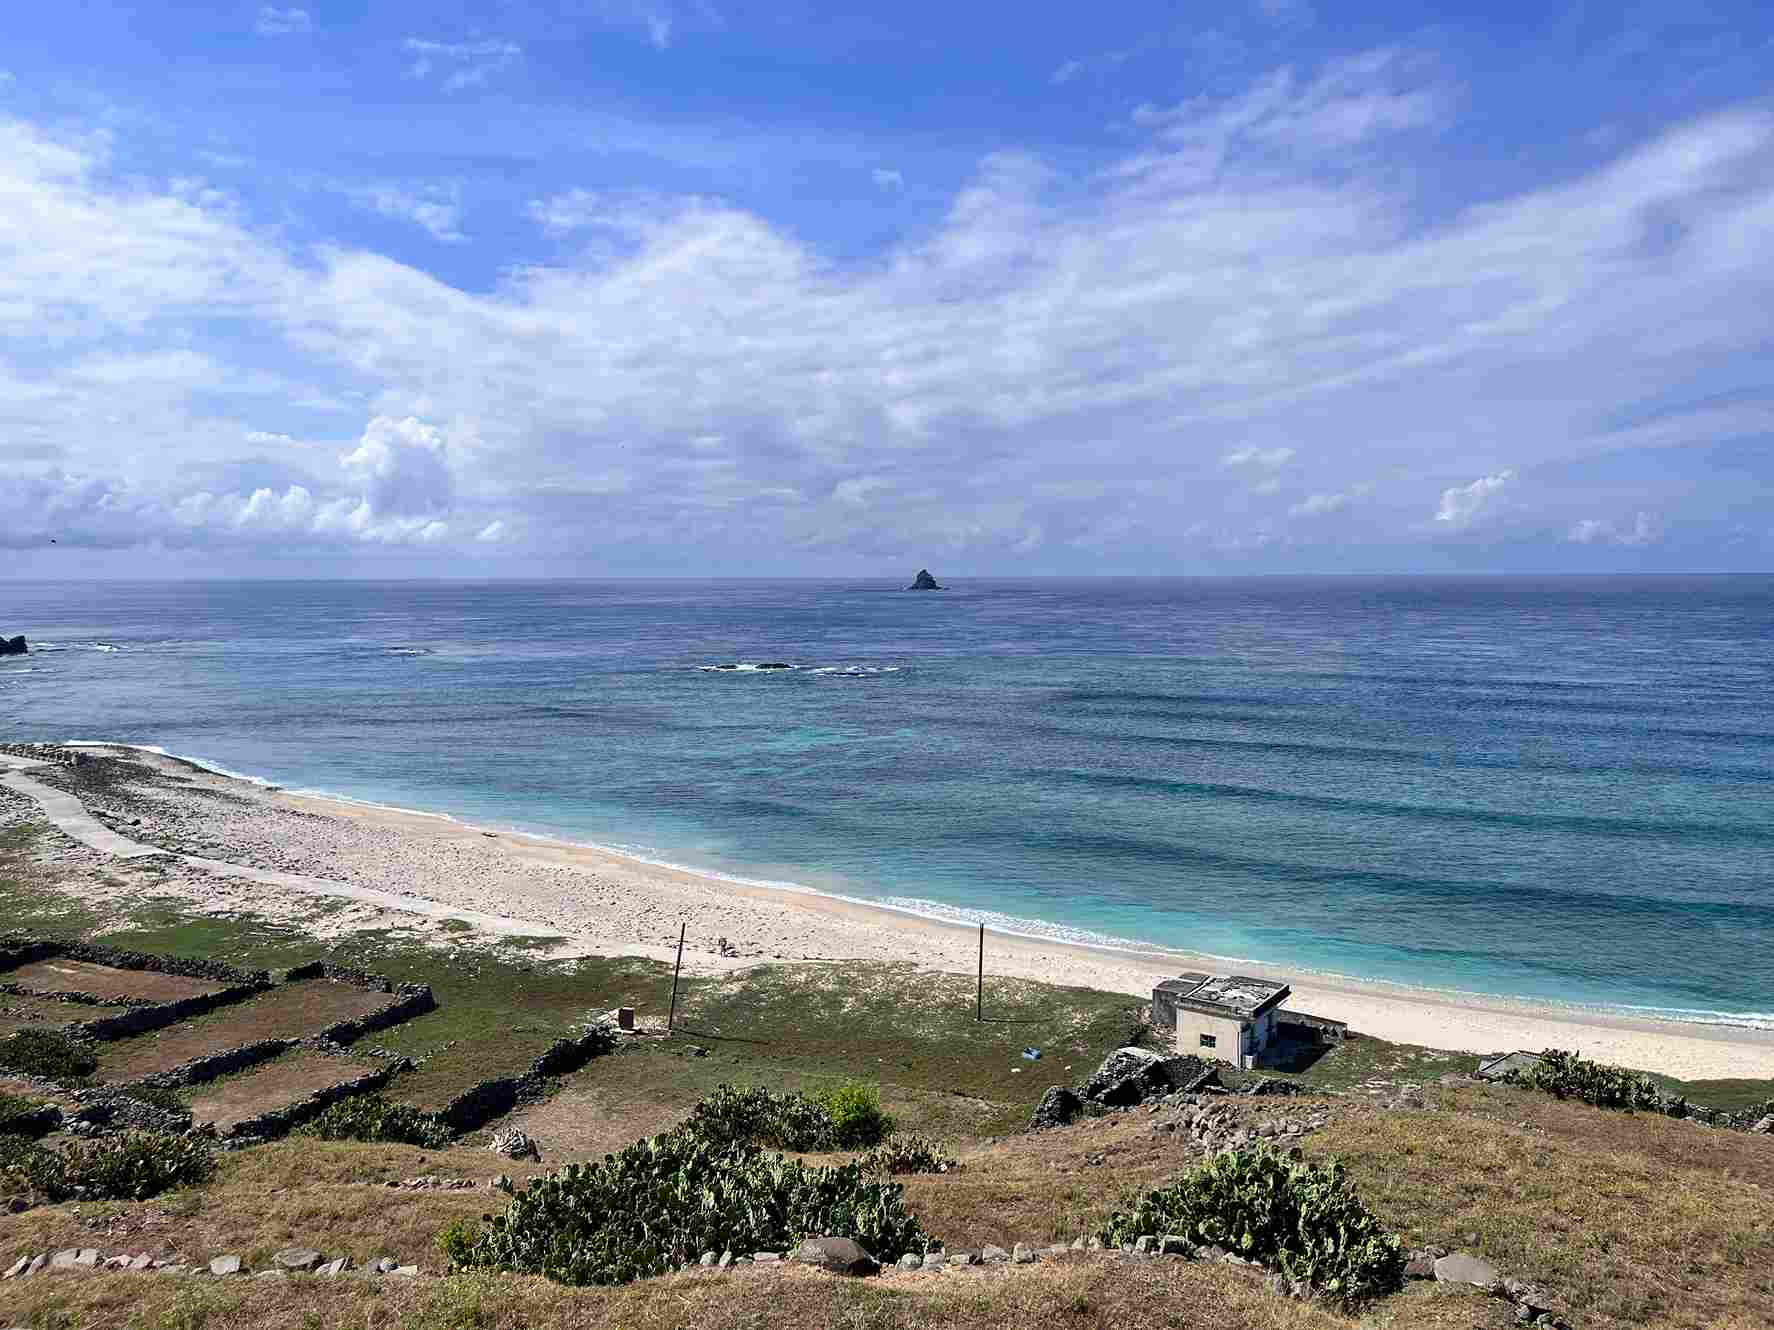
1307, 1087, 1774, 1330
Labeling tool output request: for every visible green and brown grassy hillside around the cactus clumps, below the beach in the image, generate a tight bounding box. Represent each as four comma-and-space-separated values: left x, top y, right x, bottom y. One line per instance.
0, 808, 1774, 1330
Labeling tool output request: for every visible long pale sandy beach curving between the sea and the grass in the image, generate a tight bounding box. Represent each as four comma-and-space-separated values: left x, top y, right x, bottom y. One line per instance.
20, 750, 1774, 1078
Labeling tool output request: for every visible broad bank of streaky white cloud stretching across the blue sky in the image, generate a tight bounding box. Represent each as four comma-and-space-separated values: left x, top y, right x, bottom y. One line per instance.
0, 43, 1774, 569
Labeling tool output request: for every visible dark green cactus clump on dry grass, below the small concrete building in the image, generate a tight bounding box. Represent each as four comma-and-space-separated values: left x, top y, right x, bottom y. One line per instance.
1100, 1144, 1405, 1303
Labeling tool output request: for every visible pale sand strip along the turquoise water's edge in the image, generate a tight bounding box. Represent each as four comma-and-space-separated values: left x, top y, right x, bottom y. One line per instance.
51, 743, 1774, 1080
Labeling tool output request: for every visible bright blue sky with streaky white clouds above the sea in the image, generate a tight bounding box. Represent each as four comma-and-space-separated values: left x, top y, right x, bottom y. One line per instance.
0, 0, 1774, 578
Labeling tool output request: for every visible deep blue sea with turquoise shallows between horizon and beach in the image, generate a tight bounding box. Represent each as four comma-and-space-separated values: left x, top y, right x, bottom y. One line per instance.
0, 576, 1774, 1025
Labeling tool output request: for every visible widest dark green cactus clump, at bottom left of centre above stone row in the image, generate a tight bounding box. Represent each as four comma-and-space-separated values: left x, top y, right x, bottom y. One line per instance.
451, 1130, 931, 1284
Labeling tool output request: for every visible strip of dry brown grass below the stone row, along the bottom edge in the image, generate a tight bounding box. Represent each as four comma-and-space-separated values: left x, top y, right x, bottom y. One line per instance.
0, 1257, 1369, 1330
